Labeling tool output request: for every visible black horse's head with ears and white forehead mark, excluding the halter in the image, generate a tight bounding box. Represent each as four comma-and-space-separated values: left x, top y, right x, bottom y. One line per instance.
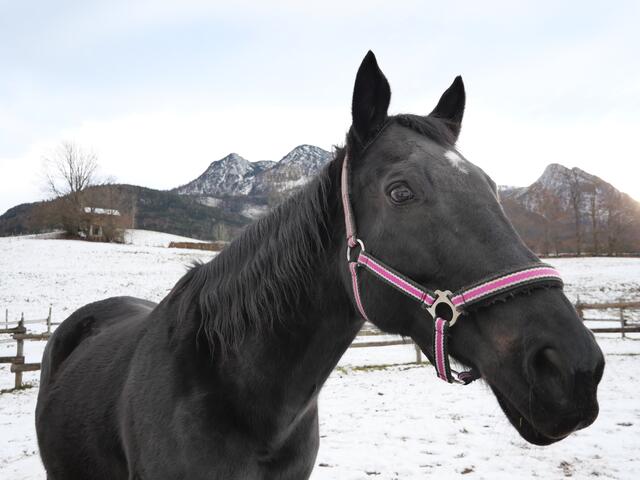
343, 52, 604, 445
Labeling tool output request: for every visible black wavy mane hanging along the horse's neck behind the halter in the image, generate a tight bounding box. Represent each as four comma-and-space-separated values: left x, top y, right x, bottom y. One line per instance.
167, 148, 346, 356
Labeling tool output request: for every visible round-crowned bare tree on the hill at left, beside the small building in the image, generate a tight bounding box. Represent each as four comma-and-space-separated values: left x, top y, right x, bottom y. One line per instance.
43, 142, 98, 235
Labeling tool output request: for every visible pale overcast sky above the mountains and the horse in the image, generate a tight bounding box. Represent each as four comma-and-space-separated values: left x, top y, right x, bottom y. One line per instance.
0, 0, 640, 213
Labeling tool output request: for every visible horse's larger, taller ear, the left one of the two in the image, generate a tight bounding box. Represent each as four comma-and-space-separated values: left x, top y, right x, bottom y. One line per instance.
351, 50, 391, 144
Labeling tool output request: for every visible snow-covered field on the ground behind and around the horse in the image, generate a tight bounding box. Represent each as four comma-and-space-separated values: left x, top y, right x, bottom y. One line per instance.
0, 236, 640, 480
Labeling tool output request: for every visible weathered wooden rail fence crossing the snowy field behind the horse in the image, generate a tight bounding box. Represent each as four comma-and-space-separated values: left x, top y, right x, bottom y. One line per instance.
0, 301, 640, 388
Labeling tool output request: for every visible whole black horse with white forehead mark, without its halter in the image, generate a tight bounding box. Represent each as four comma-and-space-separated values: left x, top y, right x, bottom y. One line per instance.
36, 52, 604, 480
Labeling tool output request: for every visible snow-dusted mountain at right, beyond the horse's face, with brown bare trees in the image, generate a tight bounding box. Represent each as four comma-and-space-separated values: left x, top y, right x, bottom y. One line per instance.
500, 163, 640, 254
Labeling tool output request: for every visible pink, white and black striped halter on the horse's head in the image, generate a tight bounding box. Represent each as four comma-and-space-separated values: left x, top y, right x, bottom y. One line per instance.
341, 153, 563, 385
